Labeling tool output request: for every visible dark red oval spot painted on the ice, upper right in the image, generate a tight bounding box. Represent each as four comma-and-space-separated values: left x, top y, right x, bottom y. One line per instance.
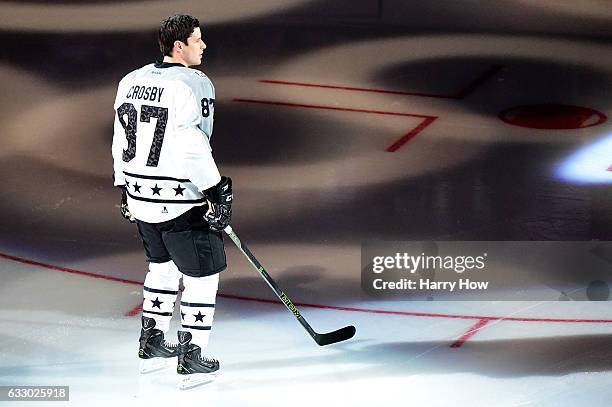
498, 104, 608, 130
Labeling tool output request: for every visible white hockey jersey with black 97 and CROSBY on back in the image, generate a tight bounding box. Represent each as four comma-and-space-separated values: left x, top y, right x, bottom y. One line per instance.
112, 62, 221, 223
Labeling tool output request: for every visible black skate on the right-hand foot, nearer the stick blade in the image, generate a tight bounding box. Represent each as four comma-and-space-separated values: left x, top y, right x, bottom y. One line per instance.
176, 331, 219, 390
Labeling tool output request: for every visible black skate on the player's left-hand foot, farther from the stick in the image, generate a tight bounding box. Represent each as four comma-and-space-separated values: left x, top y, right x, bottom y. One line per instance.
138, 316, 178, 373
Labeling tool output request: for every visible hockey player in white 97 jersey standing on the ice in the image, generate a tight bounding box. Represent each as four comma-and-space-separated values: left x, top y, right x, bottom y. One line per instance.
112, 15, 232, 388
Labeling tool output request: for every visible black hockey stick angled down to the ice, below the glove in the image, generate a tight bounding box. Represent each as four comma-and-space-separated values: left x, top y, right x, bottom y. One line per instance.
223, 226, 355, 346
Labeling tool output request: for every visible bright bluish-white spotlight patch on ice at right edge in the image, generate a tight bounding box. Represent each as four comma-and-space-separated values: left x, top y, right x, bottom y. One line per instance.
556, 134, 612, 184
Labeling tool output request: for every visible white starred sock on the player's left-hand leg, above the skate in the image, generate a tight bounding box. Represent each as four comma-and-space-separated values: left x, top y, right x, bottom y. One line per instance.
142, 261, 181, 333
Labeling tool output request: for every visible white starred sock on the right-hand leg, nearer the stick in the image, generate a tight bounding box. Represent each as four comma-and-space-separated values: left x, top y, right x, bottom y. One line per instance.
181, 274, 219, 349
